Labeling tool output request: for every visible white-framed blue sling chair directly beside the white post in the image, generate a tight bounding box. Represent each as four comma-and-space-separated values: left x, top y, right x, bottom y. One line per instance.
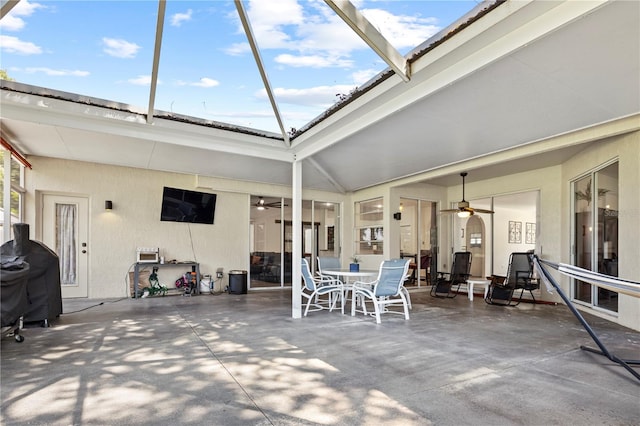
302, 258, 344, 317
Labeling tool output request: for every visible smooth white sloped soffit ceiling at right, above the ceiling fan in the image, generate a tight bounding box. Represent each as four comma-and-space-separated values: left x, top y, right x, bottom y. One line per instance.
302, 2, 640, 189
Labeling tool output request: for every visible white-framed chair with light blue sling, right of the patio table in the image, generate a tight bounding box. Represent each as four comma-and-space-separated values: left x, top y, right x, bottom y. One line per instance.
351, 259, 409, 324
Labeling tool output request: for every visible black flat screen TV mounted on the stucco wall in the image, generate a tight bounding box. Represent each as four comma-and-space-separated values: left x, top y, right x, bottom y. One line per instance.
160, 186, 217, 224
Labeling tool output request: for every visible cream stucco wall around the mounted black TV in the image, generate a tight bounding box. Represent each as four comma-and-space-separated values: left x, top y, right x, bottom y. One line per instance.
26, 157, 249, 298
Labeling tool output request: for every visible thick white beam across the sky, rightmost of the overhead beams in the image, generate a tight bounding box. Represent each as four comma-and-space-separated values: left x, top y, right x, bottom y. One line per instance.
325, 0, 411, 82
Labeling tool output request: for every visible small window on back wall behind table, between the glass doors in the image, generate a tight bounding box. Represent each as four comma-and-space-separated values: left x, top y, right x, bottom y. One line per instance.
354, 198, 384, 255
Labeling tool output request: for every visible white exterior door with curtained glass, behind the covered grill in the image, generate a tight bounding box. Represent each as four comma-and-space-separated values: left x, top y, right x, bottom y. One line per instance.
41, 194, 89, 299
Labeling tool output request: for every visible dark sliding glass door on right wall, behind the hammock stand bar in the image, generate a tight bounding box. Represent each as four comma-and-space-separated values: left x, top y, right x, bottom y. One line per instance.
572, 162, 618, 312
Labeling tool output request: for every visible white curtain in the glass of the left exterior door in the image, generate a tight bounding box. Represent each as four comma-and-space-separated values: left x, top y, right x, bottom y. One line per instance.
56, 204, 78, 284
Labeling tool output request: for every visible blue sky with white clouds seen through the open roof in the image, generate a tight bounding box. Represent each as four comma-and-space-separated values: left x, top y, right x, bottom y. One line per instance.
0, 0, 478, 132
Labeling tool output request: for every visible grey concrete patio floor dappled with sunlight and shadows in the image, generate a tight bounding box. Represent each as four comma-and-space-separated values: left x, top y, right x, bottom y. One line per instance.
1, 289, 640, 426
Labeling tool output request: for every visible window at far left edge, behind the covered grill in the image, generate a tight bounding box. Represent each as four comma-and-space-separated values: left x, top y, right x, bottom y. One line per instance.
0, 149, 25, 241
